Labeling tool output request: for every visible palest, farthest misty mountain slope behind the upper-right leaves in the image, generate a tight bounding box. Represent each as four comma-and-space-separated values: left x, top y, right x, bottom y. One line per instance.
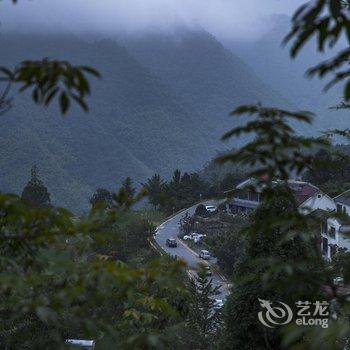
230, 15, 348, 133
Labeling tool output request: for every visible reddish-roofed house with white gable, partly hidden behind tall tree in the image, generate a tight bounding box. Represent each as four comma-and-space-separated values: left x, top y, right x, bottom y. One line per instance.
228, 179, 336, 214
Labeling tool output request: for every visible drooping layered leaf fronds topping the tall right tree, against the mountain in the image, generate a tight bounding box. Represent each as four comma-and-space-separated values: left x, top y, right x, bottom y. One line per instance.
218, 105, 328, 181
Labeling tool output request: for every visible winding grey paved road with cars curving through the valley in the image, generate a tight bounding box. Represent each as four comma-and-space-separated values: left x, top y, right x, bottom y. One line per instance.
154, 201, 230, 299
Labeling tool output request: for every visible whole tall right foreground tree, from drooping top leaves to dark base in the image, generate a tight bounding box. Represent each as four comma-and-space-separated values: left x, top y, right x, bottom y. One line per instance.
219, 105, 349, 350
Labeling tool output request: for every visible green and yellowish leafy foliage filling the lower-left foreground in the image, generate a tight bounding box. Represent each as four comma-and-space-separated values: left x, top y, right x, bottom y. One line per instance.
0, 195, 189, 349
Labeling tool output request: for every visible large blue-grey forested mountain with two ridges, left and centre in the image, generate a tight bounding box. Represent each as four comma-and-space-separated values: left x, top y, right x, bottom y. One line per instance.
0, 33, 288, 210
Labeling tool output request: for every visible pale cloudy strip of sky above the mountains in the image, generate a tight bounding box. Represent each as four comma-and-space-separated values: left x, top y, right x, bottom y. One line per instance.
0, 0, 306, 40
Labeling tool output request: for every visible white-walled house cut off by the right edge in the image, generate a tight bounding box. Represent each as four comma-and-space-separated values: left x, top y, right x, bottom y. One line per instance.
321, 190, 350, 260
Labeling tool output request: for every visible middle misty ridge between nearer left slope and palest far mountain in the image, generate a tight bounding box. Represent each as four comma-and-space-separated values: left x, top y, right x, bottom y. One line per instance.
123, 31, 293, 138
